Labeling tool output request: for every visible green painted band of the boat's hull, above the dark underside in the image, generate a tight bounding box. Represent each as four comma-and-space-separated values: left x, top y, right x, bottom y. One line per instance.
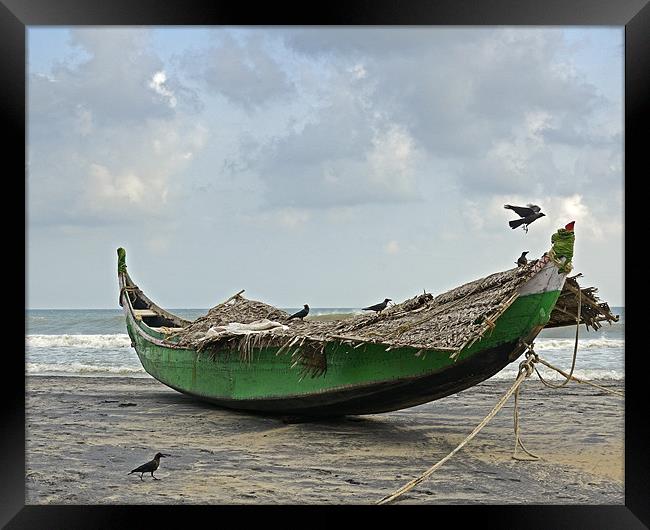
127, 291, 560, 400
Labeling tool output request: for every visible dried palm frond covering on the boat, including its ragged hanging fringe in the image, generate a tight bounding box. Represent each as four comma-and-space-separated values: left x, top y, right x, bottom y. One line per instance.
167, 260, 618, 377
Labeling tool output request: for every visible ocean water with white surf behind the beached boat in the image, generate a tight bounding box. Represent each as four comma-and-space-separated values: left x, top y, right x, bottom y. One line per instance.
25, 307, 625, 380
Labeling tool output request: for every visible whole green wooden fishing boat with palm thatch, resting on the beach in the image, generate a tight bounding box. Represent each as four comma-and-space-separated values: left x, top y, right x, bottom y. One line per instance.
118, 225, 616, 416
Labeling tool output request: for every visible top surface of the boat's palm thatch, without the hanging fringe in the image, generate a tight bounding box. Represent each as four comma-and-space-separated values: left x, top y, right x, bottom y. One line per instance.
171, 261, 535, 352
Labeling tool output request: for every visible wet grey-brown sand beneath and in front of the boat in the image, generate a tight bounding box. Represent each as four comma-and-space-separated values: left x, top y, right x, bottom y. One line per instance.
26, 376, 624, 505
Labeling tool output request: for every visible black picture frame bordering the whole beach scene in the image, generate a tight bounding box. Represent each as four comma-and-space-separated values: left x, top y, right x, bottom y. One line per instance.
5, 0, 650, 530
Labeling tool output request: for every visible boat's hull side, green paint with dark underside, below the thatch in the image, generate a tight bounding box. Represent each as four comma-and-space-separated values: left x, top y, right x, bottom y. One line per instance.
126, 290, 560, 416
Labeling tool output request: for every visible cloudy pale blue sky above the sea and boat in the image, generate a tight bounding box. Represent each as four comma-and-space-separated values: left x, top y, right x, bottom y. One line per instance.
27, 27, 624, 308
